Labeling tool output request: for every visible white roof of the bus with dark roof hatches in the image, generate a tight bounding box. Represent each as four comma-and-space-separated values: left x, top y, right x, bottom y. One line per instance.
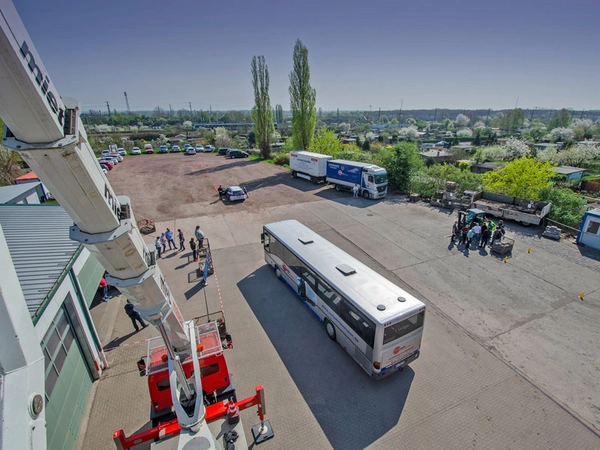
264, 220, 425, 325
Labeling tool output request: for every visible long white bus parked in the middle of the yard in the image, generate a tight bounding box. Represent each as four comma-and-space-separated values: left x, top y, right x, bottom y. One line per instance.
261, 220, 425, 378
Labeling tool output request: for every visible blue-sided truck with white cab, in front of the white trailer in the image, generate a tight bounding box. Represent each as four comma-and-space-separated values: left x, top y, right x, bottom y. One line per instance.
326, 158, 387, 199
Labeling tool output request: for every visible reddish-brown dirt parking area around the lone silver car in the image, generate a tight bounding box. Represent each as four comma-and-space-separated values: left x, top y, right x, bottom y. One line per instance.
107, 153, 332, 222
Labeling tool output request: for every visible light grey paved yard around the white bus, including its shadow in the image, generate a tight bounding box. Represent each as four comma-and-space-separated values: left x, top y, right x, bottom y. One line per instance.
81, 155, 600, 450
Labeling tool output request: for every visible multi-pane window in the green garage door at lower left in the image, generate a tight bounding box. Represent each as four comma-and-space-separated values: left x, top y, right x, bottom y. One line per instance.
42, 309, 74, 403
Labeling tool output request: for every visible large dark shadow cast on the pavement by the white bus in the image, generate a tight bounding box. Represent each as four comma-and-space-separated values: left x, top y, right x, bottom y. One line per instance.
238, 265, 414, 450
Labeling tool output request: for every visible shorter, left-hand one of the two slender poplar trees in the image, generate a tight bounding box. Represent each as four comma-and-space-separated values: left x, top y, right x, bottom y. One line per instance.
252, 55, 275, 159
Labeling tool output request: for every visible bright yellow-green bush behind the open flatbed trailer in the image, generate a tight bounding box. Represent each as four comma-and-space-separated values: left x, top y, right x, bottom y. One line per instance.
483, 156, 555, 200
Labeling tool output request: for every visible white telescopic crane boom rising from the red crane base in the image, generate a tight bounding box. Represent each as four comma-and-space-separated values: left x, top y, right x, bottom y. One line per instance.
0, 0, 214, 450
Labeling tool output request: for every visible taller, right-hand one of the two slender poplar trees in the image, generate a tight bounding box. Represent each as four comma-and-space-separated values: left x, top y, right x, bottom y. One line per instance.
289, 39, 317, 150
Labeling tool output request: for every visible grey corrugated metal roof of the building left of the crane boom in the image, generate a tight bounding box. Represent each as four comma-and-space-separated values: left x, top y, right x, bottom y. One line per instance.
0, 205, 80, 317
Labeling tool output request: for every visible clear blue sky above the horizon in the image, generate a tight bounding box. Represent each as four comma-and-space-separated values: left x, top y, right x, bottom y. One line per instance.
14, 0, 600, 111
